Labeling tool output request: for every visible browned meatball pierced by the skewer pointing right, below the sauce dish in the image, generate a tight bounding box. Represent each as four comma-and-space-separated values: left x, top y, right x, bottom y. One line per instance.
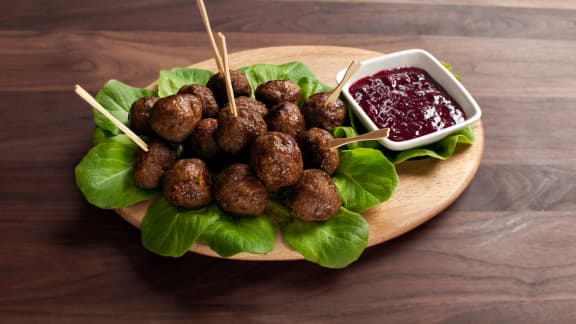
300, 127, 340, 175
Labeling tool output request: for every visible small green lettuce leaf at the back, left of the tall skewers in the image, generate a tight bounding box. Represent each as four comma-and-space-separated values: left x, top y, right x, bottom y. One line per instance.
158, 68, 214, 97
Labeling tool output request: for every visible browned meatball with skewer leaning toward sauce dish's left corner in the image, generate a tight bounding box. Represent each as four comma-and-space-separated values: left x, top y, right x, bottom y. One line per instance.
302, 92, 346, 130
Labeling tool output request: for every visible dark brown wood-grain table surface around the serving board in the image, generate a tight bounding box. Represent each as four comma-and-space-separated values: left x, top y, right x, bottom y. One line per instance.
0, 0, 576, 323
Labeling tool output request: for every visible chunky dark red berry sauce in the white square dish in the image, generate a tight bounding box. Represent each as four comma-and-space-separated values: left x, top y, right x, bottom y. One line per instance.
350, 67, 466, 141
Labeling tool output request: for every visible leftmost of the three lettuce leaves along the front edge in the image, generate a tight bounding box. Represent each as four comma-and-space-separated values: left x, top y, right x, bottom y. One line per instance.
141, 198, 221, 257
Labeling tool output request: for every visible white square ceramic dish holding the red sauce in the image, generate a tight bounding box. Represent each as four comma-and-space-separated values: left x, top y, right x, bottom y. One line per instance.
336, 49, 482, 151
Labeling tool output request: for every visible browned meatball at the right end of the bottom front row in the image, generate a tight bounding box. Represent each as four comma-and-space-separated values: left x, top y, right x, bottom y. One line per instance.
284, 169, 342, 221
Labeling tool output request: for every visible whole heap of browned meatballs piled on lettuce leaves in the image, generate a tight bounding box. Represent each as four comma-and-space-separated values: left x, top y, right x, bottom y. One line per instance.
129, 71, 347, 221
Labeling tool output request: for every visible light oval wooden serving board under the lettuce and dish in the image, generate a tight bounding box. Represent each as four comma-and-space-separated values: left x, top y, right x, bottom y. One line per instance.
117, 46, 484, 260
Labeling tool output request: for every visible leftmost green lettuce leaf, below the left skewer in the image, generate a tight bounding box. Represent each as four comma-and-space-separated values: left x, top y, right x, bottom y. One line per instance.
74, 135, 156, 209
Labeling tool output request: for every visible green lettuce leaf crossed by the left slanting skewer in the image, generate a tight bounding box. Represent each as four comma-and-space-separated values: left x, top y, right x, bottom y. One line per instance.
93, 80, 156, 136
